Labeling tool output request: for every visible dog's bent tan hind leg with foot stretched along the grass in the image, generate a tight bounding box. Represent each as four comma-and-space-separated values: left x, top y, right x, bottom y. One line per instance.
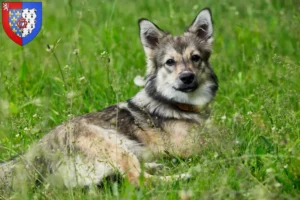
74, 122, 190, 186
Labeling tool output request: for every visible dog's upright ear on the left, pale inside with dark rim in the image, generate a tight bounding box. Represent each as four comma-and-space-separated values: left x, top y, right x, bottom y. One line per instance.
139, 19, 167, 55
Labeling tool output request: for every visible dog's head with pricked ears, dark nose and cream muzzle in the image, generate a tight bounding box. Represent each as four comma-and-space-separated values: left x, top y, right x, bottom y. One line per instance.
139, 8, 218, 105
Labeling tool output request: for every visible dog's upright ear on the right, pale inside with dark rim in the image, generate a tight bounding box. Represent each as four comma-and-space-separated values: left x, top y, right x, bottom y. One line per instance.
187, 8, 213, 42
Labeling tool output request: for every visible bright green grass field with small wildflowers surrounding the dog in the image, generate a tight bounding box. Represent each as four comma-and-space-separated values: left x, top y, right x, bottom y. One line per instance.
0, 0, 300, 199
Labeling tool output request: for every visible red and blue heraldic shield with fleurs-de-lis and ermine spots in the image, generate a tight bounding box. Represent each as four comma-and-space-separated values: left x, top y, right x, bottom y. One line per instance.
2, 2, 42, 46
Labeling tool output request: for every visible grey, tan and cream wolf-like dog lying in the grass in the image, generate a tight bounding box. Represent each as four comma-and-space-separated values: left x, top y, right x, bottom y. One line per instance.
0, 8, 218, 189
